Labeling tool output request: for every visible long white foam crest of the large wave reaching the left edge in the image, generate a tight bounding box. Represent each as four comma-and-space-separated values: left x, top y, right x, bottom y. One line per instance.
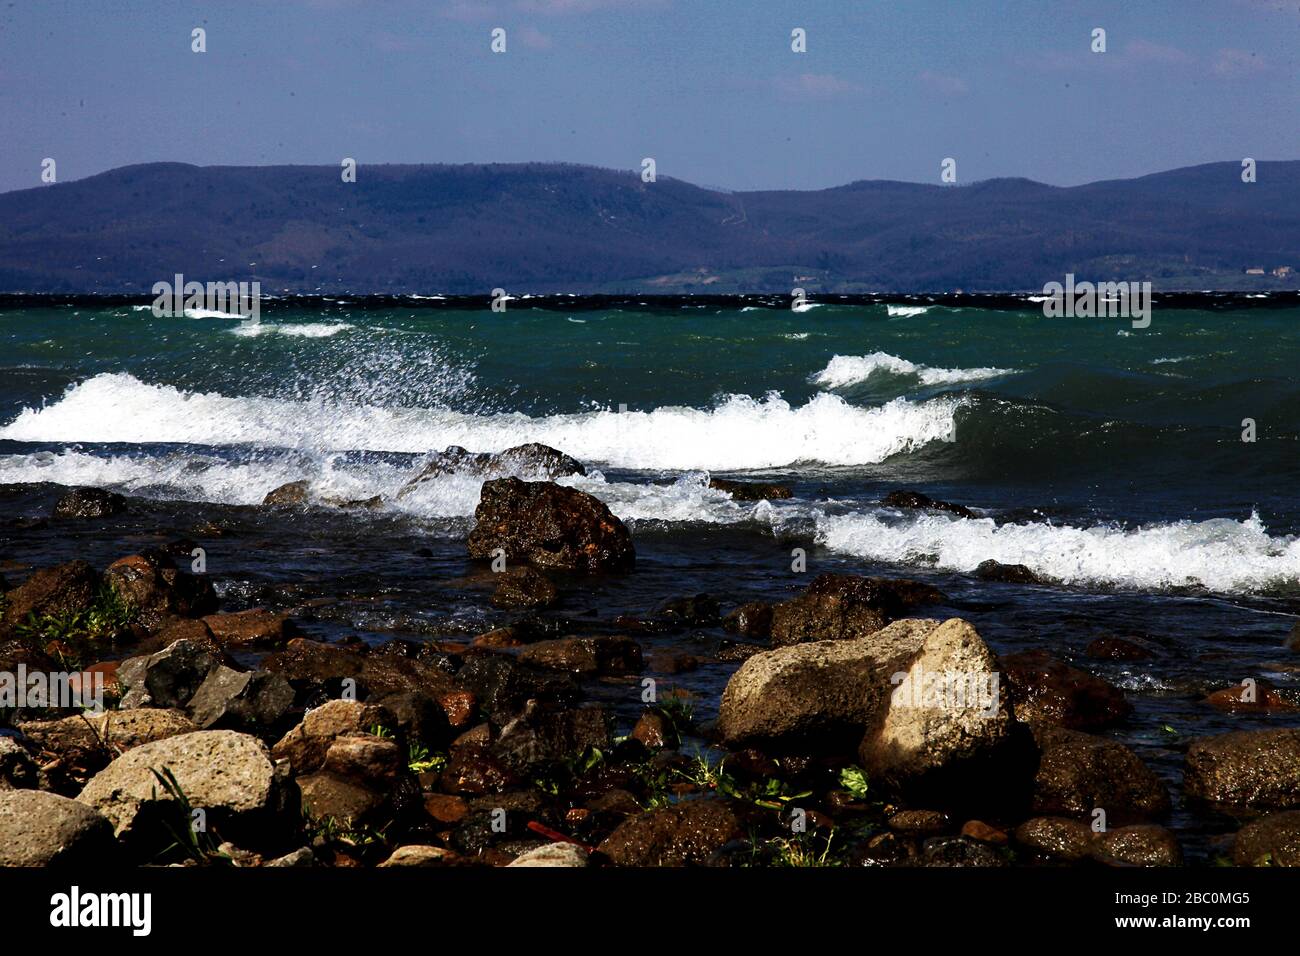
0, 373, 962, 470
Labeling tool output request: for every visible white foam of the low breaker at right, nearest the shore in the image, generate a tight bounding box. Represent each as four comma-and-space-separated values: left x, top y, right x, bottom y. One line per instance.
816, 512, 1300, 592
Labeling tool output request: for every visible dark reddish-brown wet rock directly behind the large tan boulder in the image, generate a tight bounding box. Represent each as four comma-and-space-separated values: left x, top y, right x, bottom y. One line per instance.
771, 574, 943, 646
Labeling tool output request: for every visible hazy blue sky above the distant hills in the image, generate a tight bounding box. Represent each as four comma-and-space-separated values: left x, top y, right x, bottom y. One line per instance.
0, 0, 1300, 191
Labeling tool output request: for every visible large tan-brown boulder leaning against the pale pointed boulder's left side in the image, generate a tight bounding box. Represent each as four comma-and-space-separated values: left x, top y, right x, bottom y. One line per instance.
718, 620, 939, 753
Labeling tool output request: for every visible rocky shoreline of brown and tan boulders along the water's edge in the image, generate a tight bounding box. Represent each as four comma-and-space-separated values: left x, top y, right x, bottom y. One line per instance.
0, 445, 1300, 866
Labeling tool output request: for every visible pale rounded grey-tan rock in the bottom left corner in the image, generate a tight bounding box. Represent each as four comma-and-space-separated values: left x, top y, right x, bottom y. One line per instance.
0, 790, 117, 869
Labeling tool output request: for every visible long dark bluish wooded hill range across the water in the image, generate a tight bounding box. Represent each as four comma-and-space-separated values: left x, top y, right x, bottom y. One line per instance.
0, 161, 1300, 294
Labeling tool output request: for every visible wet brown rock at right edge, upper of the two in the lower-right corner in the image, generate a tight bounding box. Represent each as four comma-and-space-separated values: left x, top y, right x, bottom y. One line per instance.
1183, 728, 1300, 810
